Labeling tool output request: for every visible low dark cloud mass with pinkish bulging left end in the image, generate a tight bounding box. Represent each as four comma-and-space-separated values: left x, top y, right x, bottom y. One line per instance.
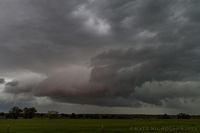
36, 42, 200, 106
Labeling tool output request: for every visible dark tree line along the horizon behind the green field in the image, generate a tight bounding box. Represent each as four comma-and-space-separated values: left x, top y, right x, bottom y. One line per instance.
0, 106, 197, 119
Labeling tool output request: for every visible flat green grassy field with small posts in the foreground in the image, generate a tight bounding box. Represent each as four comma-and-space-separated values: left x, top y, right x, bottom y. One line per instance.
0, 119, 200, 133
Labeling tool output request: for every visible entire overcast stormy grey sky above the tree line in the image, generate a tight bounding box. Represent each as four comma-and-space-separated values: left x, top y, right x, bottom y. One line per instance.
0, 0, 200, 114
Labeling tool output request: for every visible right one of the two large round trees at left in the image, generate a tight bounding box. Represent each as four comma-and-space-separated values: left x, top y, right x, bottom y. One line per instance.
23, 107, 37, 119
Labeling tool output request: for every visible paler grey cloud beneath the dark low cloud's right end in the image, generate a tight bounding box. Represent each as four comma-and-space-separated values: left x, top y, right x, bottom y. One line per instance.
130, 81, 200, 108
